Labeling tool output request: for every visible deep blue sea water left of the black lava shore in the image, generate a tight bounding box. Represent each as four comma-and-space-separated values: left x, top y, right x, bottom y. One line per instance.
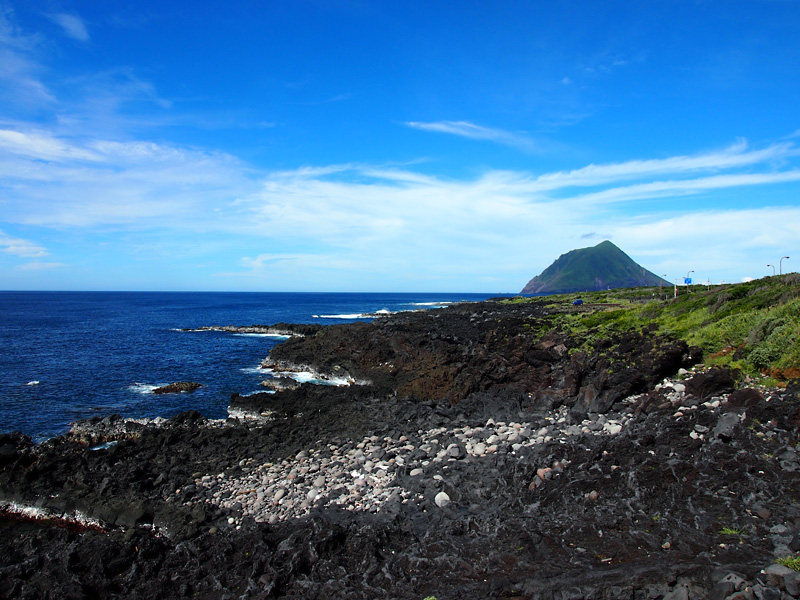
0, 292, 496, 441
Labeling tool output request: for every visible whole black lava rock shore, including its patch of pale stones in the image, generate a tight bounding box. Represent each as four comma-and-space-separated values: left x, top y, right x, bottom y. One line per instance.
0, 281, 800, 600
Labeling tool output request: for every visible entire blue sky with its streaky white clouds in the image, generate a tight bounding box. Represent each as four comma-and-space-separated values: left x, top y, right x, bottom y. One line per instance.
0, 0, 800, 293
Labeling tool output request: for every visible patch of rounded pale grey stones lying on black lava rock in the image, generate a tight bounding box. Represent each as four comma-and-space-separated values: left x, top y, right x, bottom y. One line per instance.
184, 390, 680, 526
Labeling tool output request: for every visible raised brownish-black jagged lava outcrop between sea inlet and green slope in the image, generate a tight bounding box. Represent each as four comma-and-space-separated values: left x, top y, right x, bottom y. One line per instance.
253, 302, 699, 413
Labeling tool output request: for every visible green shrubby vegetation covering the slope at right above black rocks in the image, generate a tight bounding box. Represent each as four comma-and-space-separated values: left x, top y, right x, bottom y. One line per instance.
509, 273, 800, 384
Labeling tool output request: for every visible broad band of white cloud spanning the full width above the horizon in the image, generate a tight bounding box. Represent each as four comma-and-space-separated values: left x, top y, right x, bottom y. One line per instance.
0, 119, 800, 292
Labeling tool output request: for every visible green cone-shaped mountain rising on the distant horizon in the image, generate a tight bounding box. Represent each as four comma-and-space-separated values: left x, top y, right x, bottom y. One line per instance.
521, 240, 669, 295
